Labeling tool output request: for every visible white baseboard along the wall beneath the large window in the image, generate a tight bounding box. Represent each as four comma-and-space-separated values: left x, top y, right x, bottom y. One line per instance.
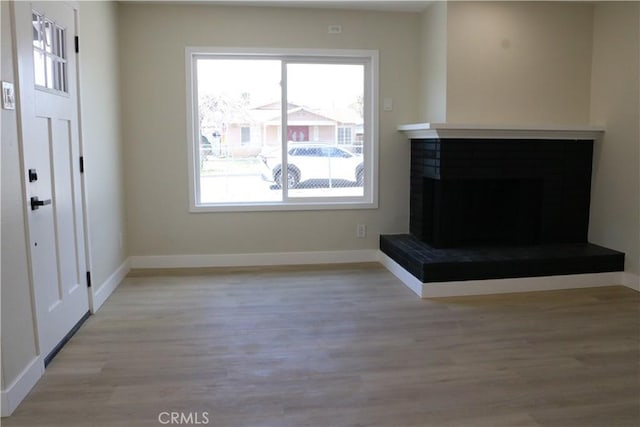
130, 249, 378, 269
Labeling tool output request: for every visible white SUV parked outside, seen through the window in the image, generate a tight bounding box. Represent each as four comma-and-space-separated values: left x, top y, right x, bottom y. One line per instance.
260, 143, 364, 188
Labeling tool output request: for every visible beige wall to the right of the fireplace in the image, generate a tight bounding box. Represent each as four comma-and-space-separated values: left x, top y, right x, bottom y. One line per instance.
589, 2, 640, 275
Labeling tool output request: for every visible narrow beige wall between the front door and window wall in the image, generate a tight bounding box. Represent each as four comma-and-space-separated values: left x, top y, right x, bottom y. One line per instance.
80, 1, 128, 298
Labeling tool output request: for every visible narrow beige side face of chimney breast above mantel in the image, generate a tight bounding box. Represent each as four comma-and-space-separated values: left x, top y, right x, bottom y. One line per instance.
418, 2, 447, 123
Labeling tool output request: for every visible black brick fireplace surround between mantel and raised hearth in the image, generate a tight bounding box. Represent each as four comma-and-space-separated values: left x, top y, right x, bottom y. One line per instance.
410, 139, 593, 248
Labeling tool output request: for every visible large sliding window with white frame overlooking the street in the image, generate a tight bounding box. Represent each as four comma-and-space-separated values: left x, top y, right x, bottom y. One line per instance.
187, 48, 377, 211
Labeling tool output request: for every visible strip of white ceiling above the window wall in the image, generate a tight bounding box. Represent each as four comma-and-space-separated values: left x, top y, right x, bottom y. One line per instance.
121, 0, 433, 12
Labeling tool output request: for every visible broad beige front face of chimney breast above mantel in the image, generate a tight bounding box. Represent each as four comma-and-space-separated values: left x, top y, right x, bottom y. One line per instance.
446, 2, 593, 125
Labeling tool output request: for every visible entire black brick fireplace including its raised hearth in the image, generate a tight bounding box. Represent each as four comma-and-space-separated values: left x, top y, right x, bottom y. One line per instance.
380, 125, 624, 283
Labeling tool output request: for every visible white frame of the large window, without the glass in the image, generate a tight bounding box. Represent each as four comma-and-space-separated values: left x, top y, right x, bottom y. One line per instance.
185, 47, 378, 213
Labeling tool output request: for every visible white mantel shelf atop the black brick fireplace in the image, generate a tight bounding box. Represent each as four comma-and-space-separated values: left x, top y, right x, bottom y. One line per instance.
398, 123, 605, 140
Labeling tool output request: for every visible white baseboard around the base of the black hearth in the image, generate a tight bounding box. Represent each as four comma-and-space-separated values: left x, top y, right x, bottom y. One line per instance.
379, 252, 637, 298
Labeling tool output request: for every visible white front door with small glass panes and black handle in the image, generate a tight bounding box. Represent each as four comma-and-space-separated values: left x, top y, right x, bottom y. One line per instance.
13, 2, 89, 362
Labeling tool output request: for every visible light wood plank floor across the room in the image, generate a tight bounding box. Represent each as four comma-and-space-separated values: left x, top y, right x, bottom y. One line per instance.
2, 265, 640, 427
